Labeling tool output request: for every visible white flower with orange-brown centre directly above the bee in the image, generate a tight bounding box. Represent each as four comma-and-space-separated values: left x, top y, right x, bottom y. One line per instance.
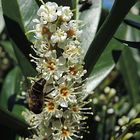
31, 50, 66, 80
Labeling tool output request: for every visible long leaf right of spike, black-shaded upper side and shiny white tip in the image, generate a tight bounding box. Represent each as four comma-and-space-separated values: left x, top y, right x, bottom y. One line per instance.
85, 0, 136, 91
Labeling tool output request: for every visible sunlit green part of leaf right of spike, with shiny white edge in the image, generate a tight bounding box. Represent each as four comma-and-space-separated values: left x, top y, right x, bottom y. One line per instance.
87, 25, 126, 91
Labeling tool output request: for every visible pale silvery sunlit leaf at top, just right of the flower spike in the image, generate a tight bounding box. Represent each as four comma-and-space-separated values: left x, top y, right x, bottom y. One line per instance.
79, 0, 102, 54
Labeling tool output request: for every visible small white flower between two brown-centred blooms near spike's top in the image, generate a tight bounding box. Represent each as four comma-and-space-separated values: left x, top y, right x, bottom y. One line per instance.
51, 29, 67, 43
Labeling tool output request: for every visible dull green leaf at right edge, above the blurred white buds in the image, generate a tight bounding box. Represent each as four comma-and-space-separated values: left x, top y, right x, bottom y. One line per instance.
119, 48, 140, 105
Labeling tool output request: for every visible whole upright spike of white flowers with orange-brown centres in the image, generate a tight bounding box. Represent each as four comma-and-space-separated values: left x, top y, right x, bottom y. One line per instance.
23, 2, 92, 140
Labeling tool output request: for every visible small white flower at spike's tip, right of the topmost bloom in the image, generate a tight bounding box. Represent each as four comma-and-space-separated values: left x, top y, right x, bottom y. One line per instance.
57, 6, 73, 21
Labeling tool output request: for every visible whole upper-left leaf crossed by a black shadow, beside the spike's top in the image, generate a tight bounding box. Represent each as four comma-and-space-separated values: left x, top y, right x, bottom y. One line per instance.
2, 0, 38, 76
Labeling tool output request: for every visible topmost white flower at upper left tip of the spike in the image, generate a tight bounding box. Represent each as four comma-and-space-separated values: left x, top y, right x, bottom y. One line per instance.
37, 2, 58, 24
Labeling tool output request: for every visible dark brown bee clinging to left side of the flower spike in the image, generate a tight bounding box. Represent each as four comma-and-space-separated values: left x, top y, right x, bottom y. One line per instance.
28, 78, 46, 114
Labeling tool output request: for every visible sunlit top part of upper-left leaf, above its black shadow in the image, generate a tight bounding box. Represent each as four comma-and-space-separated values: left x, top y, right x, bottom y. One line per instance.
2, 0, 38, 32
